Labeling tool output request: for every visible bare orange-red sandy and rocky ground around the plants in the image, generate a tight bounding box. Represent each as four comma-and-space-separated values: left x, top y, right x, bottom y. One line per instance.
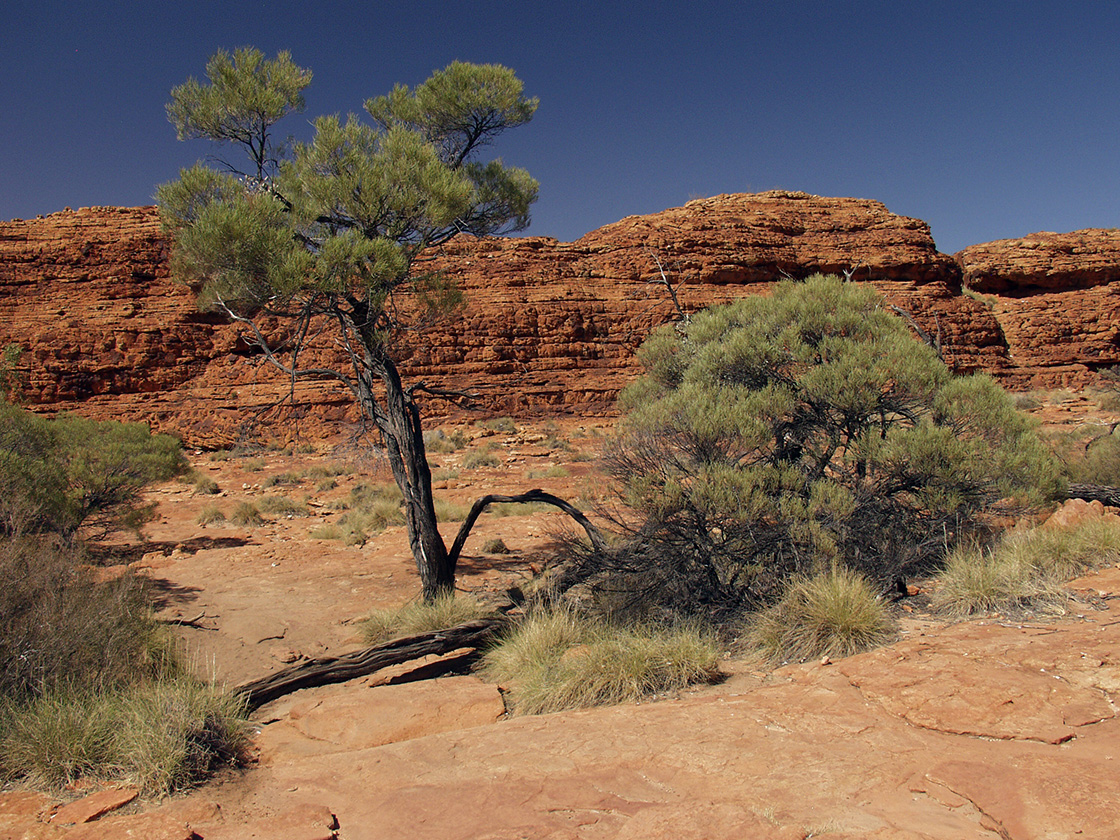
0, 405, 1120, 840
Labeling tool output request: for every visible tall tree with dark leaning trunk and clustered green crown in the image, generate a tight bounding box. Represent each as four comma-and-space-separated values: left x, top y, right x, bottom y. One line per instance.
157, 49, 600, 598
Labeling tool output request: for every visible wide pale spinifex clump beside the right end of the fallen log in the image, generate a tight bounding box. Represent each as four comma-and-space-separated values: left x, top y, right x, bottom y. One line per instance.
483, 610, 719, 715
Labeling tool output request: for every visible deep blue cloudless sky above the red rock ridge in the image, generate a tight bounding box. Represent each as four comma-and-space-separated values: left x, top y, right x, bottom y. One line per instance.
0, 0, 1120, 253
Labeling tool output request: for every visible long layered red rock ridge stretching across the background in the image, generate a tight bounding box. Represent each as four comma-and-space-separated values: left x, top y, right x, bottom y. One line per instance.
0, 192, 1120, 446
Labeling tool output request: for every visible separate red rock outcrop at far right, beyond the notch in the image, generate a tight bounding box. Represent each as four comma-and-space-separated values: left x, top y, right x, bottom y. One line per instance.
955, 228, 1120, 386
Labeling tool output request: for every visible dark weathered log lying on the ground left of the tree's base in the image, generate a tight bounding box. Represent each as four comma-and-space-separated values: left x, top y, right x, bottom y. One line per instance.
233, 617, 505, 710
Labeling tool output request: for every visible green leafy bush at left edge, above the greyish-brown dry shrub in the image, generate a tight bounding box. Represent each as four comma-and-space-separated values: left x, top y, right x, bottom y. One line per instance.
0, 402, 187, 538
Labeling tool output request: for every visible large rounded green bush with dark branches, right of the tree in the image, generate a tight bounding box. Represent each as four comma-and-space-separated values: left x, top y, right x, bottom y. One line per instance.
584, 276, 1058, 615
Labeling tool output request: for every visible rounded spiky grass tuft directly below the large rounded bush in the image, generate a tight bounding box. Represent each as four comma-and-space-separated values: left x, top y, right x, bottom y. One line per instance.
746, 567, 894, 662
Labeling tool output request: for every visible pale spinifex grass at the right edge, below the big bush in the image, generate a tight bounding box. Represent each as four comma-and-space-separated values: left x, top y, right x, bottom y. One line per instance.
933, 519, 1120, 616
